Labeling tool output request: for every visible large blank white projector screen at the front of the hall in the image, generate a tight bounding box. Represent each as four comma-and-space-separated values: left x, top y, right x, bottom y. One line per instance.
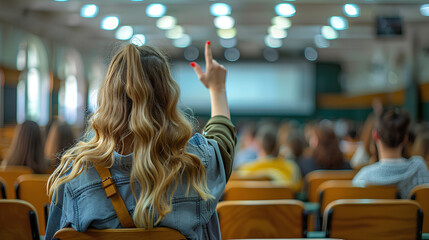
171, 61, 315, 115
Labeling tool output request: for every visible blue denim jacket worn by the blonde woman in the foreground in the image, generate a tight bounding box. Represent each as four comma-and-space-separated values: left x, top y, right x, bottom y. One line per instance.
45, 133, 227, 239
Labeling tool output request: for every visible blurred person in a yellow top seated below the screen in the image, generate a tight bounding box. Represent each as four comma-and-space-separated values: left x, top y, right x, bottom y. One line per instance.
238, 125, 301, 191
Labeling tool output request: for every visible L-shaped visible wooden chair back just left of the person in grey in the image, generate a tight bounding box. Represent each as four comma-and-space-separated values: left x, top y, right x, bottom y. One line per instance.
305, 170, 356, 203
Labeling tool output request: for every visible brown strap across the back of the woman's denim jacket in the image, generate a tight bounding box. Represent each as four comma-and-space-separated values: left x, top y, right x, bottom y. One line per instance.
95, 166, 136, 228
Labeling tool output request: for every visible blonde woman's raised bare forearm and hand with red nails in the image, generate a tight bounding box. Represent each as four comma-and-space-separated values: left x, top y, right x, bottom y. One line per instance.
191, 41, 231, 119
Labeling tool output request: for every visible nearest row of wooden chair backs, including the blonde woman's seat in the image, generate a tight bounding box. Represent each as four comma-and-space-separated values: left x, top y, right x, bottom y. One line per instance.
0, 199, 423, 240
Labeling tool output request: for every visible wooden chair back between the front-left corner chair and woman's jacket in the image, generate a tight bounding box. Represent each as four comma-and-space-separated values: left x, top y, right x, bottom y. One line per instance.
15, 174, 50, 235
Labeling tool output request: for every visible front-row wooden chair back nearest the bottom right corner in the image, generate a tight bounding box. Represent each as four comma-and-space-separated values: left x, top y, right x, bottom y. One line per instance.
323, 199, 423, 240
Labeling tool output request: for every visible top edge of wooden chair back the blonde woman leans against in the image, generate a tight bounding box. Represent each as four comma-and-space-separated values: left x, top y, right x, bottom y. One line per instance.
54, 227, 186, 240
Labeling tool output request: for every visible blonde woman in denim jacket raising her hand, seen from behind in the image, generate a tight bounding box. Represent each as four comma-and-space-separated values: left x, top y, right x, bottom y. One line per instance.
46, 42, 235, 239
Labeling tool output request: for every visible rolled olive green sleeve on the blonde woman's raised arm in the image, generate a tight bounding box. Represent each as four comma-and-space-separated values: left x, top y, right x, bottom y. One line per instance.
203, 115, 237, 180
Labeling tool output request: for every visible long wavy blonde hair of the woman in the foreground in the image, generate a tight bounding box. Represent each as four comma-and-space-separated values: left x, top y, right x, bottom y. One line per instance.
48, 44, 213, 229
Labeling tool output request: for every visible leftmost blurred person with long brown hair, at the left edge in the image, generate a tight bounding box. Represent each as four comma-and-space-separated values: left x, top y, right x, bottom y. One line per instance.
2, 120, 48, 173
